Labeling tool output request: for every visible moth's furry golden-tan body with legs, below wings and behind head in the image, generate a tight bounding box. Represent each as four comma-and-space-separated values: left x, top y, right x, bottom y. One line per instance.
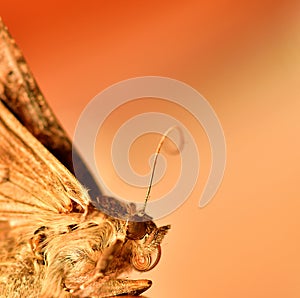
0, 213, 162, 297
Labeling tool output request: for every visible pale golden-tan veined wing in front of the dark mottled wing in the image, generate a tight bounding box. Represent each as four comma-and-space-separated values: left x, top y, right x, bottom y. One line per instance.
0, 102, 90, 222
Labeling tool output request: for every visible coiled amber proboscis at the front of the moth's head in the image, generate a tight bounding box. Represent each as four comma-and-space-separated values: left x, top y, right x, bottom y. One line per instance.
131, 245, 161, 272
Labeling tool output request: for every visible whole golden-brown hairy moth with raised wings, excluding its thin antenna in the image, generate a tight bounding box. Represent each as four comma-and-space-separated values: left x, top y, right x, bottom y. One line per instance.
0, 20, 170, 297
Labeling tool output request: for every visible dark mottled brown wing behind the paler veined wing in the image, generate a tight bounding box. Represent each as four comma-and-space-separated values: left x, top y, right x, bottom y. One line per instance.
0, 18, 101, 198
